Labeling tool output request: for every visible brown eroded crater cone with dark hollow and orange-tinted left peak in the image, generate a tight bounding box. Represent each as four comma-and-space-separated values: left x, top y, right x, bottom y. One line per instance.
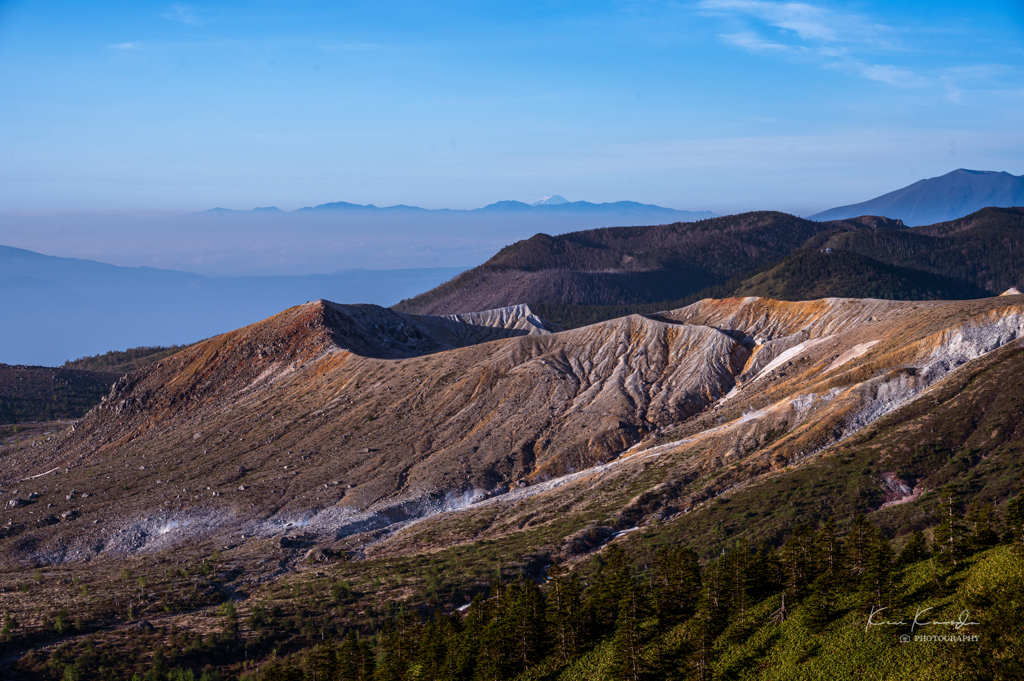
4, 302, 748, 560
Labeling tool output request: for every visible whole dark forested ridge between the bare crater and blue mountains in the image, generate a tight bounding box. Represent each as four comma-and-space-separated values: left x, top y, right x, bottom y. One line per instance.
395, 208, 1024, 329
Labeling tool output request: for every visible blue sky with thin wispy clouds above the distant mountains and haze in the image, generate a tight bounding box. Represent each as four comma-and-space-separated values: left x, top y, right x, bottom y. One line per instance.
0, 0, 1024, 215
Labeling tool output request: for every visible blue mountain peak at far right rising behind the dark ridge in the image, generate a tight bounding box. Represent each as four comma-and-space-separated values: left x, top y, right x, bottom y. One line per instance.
810, 168, 1024, 227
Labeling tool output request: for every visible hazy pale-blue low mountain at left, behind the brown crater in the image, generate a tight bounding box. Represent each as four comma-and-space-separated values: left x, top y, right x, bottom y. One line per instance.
0, 246, 462, 366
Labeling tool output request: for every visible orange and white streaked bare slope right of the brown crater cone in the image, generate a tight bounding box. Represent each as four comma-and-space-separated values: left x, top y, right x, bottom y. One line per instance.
364, 296, 1024, 559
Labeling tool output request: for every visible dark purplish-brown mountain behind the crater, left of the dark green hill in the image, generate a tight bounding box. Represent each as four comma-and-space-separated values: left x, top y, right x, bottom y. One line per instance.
395, 210, 837, 314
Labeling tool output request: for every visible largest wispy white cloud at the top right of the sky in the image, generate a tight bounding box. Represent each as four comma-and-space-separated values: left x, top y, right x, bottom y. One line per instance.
697, 0, 929, 87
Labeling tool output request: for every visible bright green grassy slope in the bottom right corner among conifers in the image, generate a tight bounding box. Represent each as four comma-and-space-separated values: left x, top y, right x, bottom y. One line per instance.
552, 547, 1024, 681
